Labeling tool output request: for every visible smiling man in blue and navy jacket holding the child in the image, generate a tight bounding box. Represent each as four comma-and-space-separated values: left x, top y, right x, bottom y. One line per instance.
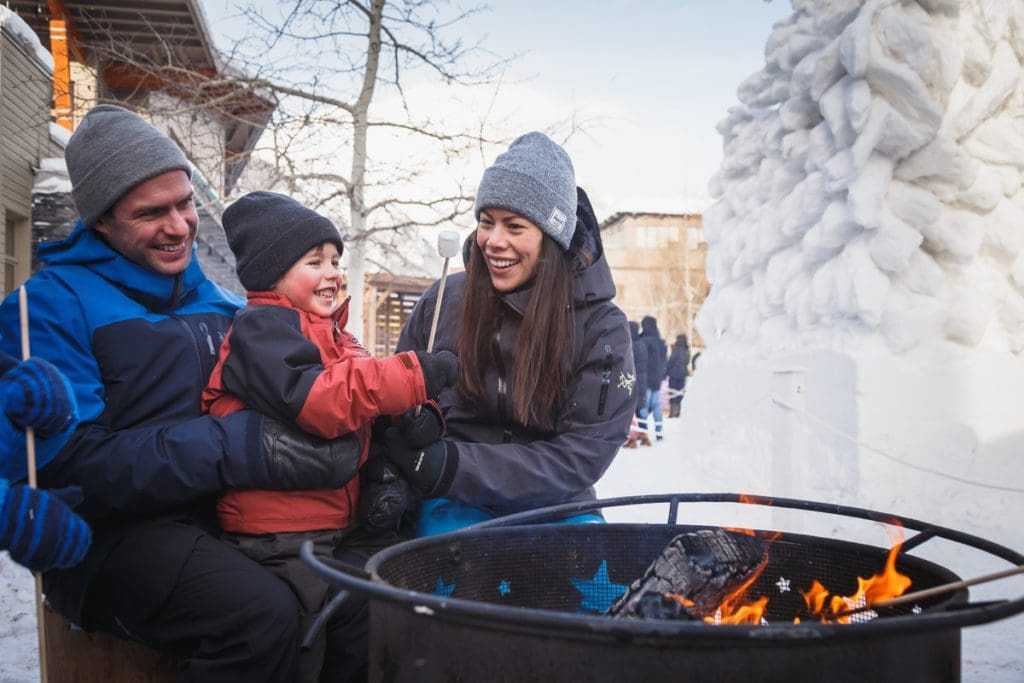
0, 104, 366, 681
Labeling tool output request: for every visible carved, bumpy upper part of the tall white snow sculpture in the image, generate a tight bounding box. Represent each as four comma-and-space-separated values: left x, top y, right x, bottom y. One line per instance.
698, 0, 1024, 353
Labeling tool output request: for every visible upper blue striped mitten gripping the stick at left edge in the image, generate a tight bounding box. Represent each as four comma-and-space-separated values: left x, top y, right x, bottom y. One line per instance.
0, 358, 78, 438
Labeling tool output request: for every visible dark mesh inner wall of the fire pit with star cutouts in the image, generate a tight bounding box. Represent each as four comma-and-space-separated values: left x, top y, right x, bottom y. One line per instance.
375, 524, 967, 624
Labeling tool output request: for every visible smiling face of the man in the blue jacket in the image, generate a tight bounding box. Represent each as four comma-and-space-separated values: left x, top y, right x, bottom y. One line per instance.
94, 171, 199, 275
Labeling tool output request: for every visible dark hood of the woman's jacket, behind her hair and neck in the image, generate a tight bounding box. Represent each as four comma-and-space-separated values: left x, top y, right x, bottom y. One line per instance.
462, 187, 615, 313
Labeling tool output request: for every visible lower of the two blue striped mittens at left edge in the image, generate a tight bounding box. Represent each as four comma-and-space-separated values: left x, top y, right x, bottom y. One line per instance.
0, 479, 92, 571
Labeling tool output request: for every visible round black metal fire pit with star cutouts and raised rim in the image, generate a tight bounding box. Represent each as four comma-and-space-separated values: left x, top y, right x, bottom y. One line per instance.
304, 494, 1024, 683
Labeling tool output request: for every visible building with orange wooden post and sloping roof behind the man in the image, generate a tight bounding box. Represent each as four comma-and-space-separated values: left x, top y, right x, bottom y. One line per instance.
0, 0, 276, 293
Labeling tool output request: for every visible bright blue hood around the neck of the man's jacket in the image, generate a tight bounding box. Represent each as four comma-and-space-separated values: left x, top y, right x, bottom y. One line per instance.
39, 219, 206, 310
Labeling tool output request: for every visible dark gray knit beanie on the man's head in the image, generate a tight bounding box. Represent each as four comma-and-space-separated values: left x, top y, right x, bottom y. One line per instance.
65, 104, 191, 227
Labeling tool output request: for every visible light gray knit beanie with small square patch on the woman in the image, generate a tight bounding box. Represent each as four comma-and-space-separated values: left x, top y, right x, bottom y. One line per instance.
476, 133, 577, 251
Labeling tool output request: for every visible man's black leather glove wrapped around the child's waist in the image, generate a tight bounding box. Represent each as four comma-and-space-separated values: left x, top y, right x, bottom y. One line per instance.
256, 417, 362, 490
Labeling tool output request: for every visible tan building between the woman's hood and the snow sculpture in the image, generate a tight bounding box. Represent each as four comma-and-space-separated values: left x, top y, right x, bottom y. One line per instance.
601, 213, 708, 346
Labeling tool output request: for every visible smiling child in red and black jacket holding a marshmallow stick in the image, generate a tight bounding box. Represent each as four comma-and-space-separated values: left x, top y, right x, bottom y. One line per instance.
203, 191, 458, 680
